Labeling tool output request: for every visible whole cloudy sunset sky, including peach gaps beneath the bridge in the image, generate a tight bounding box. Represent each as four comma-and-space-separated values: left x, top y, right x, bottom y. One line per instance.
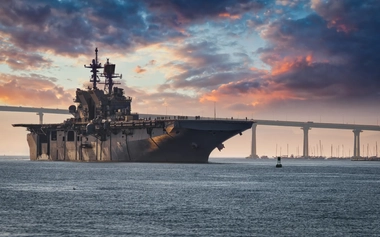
0, 0, 380, 157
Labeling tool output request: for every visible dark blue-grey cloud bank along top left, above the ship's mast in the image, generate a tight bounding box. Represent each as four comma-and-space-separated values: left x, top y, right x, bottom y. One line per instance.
0, 0, 264, 56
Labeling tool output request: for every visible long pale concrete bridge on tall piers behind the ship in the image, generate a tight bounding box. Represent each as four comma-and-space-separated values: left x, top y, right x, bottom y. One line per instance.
0, 106, 380, 158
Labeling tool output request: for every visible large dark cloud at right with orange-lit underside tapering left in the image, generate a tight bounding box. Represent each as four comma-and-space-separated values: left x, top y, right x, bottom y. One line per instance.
196, 1, 380, 110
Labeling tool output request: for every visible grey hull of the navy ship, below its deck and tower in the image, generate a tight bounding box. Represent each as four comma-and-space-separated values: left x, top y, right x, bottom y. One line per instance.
20, 120, 253, 163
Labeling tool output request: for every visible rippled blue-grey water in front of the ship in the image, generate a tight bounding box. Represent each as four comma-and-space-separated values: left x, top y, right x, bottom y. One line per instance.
0, 157, 380, 236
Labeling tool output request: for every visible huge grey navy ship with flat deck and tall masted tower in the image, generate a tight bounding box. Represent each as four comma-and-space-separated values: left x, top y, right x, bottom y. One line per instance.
13, 48, 253, 163
